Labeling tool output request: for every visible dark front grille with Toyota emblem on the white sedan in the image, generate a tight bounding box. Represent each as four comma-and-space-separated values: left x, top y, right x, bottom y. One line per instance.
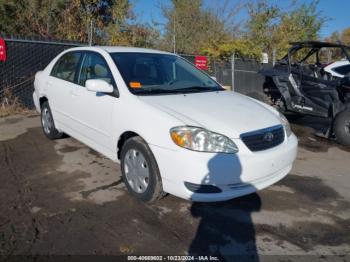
241, 125, 284, 152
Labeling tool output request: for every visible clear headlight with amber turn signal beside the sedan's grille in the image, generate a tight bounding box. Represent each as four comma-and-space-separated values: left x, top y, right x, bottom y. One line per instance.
170, 126, 238, 154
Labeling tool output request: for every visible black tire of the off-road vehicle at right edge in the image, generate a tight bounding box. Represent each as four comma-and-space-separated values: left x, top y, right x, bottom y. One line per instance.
333, 110, 350, 146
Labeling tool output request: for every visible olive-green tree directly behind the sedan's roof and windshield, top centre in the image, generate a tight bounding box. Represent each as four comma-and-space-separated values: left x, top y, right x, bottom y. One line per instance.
160, 0, 238, 54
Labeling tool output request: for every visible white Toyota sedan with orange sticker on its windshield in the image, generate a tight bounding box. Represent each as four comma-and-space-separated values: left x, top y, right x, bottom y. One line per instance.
33, 47, 298, 202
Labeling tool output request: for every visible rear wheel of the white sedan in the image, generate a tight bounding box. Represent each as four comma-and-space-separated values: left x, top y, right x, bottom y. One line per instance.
41, 101, 63, 140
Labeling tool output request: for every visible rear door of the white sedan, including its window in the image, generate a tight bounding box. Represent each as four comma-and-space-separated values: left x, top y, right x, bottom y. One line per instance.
46, 51, 82, 128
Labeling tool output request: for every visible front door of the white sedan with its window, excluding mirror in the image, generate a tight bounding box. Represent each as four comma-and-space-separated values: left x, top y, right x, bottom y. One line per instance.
72, 51, 117, 153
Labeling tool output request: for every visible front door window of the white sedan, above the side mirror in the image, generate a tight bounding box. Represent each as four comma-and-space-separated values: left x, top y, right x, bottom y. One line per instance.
78, 53, 114, 86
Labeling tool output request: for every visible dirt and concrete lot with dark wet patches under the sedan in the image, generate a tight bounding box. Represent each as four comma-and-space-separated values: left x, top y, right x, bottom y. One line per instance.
0, 115, 350, 261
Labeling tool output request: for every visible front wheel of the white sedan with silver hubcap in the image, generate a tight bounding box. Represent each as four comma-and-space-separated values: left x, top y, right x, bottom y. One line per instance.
120, 137, 164, 203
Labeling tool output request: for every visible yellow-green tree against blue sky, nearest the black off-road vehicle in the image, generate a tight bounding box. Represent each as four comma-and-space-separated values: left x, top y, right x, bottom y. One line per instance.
247, 0, 326, 57
